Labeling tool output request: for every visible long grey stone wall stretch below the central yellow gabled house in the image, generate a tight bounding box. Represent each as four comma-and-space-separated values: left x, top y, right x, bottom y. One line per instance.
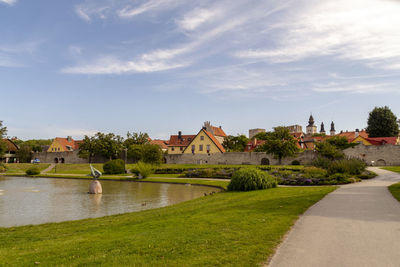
165, 151, 315, 165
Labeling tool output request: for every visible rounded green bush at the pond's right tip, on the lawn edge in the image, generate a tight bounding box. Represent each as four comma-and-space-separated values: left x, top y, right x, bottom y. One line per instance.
228, 169, 277, 191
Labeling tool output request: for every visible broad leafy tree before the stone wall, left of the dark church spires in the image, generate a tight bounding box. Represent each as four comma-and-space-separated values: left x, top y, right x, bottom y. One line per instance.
256, 126, 299, 164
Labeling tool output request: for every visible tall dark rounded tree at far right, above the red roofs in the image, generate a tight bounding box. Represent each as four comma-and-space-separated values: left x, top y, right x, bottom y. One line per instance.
366, 106, 399, 137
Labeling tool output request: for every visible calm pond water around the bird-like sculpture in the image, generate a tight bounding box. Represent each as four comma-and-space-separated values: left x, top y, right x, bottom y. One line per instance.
0, 177, 220, 227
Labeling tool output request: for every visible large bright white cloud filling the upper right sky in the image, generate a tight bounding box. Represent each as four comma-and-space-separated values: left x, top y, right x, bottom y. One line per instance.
236, 0, 400, 67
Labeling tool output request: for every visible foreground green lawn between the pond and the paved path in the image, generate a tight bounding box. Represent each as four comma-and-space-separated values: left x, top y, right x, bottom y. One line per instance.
0, 187, 335, 266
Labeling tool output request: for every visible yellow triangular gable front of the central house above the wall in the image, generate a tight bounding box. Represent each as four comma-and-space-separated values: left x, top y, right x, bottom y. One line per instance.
183, 128, 225, 154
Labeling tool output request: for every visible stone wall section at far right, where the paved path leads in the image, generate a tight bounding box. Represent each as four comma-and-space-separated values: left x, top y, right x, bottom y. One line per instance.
344, 144, 400, 166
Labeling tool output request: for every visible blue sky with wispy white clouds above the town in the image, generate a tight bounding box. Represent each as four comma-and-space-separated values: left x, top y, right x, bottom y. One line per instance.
0, 0, 400, 139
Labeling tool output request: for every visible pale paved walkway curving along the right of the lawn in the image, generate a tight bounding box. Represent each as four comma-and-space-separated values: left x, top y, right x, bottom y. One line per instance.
269, 168, 400, 267
